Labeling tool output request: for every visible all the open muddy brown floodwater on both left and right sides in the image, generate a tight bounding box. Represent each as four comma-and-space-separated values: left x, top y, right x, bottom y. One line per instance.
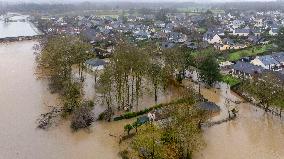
0, 41, 284, 159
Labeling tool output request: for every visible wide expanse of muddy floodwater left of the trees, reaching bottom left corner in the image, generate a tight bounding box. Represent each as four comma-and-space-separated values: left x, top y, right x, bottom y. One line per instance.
0, 41, 134, 159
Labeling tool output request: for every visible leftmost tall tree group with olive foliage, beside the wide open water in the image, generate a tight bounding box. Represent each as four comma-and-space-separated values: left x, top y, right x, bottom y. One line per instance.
37, 35, 93, 129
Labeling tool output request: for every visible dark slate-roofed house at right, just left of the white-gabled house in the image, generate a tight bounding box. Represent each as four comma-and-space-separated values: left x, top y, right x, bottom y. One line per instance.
232, 61, 264, 78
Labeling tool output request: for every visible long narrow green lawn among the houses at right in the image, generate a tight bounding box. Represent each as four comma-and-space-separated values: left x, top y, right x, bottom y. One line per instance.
227, 44, 272, 61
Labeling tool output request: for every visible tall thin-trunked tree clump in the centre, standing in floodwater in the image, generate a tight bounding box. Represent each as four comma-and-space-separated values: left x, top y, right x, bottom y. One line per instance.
97, 42, 161, 110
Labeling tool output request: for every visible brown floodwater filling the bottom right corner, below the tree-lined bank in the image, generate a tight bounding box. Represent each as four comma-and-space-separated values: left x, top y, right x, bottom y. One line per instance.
191, 81, 284, 159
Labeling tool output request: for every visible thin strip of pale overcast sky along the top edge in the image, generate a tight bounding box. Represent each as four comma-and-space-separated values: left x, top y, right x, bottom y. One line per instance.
0, 0, 275, 3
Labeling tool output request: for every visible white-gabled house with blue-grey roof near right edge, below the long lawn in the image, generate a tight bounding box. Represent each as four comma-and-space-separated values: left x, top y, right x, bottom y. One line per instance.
251, 55, 280, 70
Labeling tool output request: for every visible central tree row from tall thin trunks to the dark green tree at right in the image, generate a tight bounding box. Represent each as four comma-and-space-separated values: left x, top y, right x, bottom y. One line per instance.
97, 42, 221, 111
